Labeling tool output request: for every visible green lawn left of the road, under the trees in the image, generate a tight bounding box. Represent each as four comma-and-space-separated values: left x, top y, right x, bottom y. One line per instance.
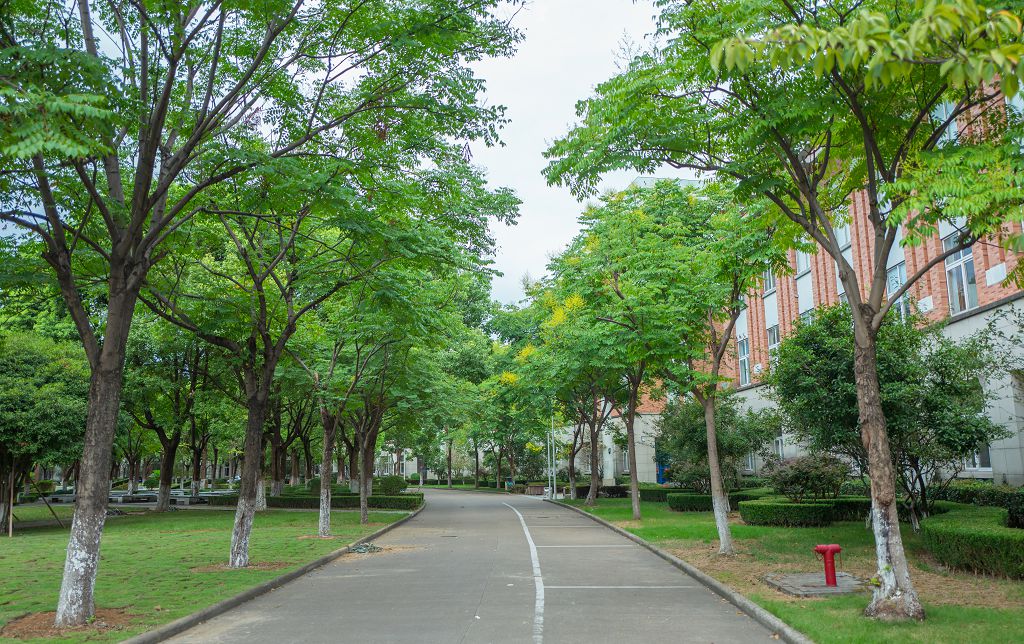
0, 508, 408, 642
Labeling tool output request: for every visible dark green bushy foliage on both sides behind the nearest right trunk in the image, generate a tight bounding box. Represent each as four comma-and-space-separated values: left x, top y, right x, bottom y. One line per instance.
765, 306, 1006, 515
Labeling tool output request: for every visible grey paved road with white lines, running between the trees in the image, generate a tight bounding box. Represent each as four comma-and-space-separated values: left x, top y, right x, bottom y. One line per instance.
172, 490, 770, 644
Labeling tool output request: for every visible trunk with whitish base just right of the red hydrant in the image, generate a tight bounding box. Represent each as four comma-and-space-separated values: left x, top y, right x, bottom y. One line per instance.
854, 331, 925, 619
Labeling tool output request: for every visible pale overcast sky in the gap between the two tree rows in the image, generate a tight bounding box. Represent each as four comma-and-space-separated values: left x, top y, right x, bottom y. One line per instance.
473, 0, 654, 302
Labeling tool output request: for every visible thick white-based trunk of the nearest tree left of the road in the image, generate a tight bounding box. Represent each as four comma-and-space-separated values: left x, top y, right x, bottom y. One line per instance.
54, 358, 126, 628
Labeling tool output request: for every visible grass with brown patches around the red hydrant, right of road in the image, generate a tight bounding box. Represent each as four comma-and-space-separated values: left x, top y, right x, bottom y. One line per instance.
569, 499, 1024, 643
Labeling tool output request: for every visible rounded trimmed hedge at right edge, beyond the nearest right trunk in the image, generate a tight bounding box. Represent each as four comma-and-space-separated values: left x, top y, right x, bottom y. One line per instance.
921, 506, 1024, 579
